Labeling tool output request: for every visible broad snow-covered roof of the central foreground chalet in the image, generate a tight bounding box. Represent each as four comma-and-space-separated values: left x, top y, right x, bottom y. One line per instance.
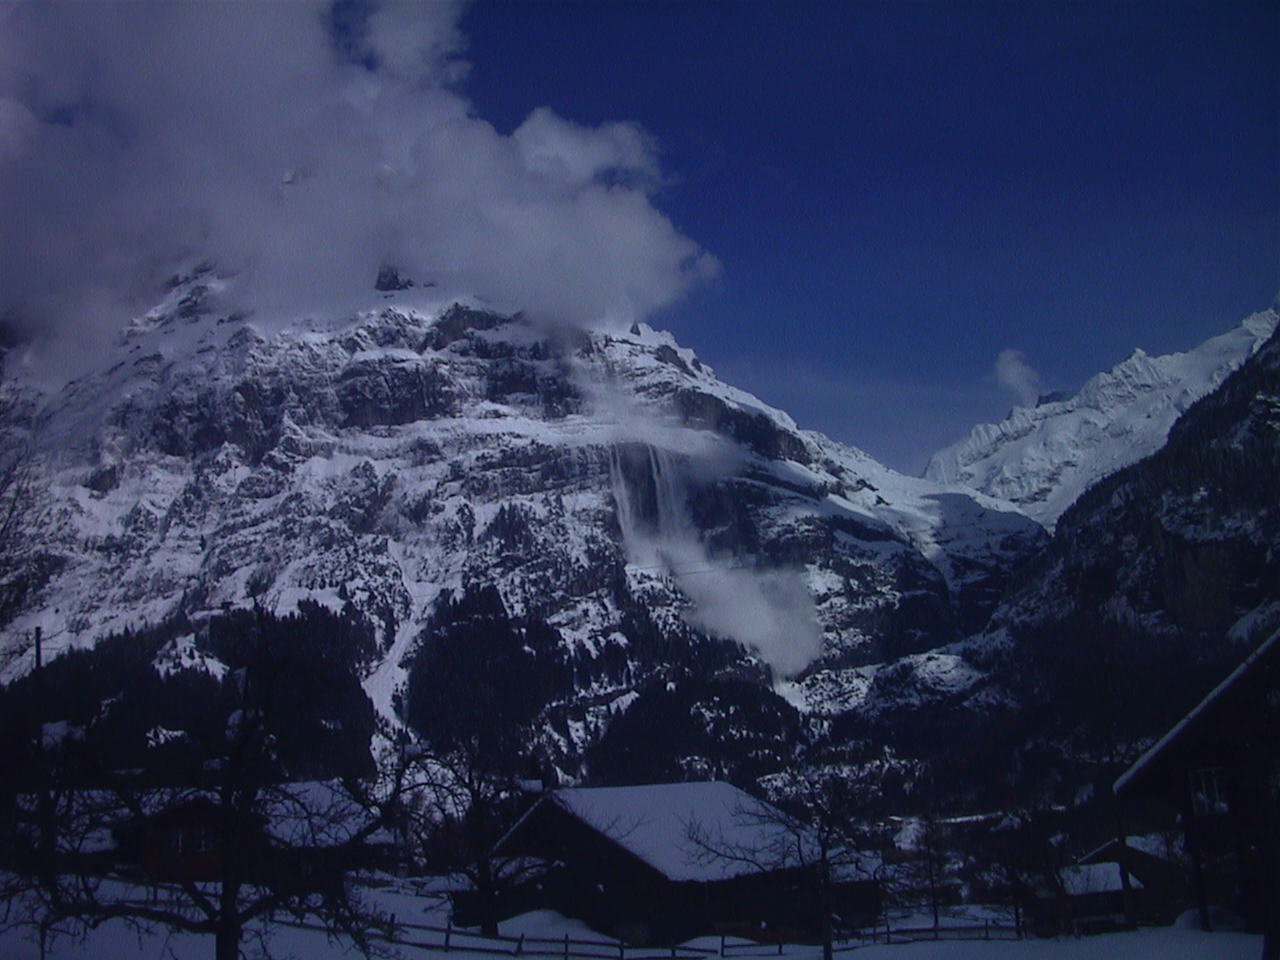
543, 781, 817, 882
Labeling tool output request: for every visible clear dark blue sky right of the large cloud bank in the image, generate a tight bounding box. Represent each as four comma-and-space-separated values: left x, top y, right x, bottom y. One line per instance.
462, 1, 1280, 471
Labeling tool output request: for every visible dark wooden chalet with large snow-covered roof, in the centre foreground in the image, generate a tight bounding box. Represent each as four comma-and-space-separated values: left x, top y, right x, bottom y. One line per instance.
497, 782, 879, 943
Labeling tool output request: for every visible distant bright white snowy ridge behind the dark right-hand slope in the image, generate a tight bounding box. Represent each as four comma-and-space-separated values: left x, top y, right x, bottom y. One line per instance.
925, 306, 1277, 527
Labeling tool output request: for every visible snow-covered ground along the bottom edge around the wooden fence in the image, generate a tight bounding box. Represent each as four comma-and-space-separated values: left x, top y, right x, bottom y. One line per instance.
0, 891, 1262, 960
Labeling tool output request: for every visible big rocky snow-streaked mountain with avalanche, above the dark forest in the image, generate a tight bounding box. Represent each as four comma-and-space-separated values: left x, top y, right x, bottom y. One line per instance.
3, 273, 1044, 773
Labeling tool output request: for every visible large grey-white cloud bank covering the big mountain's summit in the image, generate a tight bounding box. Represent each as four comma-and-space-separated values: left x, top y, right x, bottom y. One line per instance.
0, 3, 717, 378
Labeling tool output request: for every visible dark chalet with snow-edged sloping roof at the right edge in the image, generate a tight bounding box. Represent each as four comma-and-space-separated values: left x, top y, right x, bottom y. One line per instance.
1114, 632, 1280, 959
